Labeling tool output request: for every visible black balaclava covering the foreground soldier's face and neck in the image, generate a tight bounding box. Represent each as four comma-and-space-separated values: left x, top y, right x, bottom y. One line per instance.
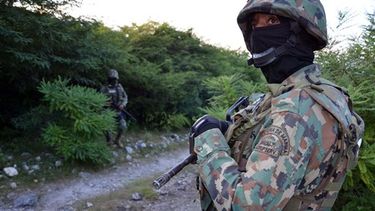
249, 17, 315, 83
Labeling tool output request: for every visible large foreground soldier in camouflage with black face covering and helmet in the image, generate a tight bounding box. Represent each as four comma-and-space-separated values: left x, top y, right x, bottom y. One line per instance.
190, 0, 364, 210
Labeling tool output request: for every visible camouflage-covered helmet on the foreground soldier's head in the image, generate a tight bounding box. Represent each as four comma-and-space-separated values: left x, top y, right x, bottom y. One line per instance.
237, 0, 328, 50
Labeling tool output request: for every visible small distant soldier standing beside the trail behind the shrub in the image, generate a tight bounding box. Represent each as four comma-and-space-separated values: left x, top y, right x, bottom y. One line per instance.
101, 69, 128, 147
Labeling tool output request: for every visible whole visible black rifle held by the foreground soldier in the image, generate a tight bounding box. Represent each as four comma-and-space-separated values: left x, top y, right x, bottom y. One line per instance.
152, 95, 264, 189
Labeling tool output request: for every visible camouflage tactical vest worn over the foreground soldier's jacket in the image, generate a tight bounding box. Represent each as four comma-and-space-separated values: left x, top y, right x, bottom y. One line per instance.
226, 71, 364, 210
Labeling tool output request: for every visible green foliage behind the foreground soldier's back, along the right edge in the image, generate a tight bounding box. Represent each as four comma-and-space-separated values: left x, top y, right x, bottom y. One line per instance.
318, 11, 375, 210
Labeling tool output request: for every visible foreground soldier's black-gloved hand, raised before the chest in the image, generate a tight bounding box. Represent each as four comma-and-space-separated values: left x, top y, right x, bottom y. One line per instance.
189, 115, 229, 163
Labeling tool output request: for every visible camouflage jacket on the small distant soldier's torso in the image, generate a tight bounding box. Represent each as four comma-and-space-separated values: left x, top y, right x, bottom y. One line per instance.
100, 83, 128, 109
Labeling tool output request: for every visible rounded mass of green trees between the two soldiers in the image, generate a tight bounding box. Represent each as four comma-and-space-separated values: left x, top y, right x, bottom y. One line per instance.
120, 22, 258, 128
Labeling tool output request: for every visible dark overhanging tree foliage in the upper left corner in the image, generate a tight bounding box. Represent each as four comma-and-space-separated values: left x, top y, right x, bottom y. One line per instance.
0, 7, 131, 132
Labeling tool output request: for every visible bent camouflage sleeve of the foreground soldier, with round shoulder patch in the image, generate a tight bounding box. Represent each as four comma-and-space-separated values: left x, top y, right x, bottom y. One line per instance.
197, 111, 316, 210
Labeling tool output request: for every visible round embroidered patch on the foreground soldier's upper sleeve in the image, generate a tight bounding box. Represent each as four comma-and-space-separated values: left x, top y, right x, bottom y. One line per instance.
254, 126, 290, 157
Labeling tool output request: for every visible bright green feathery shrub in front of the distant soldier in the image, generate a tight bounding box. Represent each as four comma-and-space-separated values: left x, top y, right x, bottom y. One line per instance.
39, 77, 116, 164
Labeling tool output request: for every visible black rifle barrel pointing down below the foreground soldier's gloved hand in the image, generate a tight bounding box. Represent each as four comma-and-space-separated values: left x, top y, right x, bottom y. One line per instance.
152, 154, 197, 189
